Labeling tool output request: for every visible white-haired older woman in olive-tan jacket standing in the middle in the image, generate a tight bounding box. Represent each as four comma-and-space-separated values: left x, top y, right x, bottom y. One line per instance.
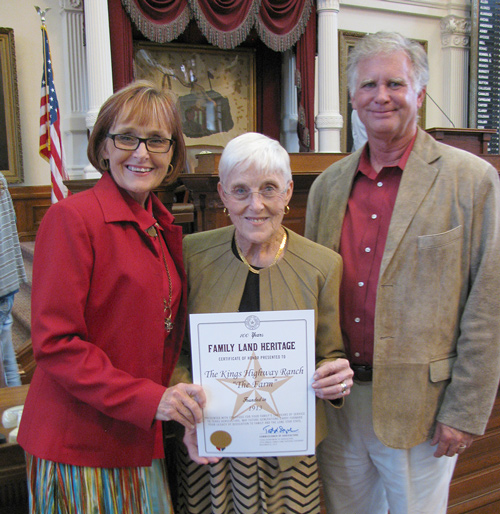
179, 133, 352, 514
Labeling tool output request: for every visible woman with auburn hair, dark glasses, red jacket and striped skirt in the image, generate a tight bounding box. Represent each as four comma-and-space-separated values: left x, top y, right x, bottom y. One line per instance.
18, 82, 205, 514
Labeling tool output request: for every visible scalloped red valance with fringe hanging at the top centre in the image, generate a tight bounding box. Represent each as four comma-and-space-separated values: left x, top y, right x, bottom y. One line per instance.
121, 0, 314, 52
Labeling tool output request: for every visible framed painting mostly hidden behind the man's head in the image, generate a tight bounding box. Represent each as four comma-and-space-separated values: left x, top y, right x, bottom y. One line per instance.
339, 30, 427, 152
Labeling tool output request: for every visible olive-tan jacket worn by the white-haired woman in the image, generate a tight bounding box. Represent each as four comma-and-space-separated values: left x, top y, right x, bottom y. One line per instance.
184, 226, 345, 463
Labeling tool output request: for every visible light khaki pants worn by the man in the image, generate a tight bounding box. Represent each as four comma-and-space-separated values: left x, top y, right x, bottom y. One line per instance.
317, 383, 457, 514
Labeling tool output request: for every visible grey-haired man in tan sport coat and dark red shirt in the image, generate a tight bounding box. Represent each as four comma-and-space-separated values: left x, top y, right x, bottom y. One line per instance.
306, 32, 500, 514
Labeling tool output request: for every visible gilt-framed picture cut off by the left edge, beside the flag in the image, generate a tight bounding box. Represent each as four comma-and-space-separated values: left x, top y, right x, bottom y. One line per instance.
0, 27, 24, 184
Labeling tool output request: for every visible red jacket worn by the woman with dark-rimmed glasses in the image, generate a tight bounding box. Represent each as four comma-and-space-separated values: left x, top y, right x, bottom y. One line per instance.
18, 173, 186, 467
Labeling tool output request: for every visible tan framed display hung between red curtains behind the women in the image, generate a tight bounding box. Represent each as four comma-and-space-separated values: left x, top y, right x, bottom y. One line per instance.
134, 42, 256, 148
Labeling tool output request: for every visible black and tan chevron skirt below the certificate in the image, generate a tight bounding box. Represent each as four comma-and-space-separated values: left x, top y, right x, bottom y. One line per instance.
176, 445, 320, 514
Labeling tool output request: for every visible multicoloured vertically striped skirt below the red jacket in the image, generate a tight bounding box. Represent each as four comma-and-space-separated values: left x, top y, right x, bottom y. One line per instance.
26, 454, 173, 514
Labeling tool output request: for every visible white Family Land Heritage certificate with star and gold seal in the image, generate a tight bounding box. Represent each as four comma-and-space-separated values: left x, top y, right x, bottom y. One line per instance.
190, 310, 316, 457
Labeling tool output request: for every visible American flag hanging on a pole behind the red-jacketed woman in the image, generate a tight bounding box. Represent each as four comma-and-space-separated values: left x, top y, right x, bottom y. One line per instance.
39, 25, 69, 203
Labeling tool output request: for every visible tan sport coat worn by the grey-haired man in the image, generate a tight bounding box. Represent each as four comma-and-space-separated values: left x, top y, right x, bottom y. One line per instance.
306, 129, 500, 448
